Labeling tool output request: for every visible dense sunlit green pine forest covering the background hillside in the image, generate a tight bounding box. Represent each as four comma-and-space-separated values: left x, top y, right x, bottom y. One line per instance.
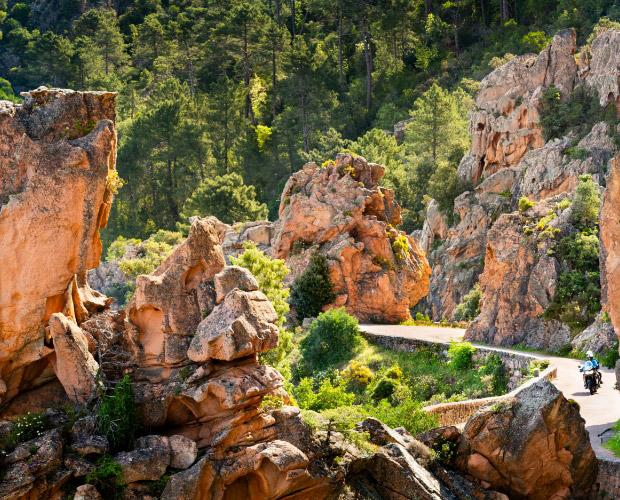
0, 0, 620, 244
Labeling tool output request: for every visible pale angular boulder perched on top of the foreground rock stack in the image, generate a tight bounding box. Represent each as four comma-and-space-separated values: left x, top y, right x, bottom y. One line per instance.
187, 288, 278, 361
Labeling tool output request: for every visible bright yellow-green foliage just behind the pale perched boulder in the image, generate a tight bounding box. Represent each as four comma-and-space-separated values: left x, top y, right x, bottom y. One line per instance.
229, 242, 289, 327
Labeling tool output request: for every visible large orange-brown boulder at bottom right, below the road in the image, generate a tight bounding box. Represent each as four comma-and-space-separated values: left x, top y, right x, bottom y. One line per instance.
457, 380, 597, 500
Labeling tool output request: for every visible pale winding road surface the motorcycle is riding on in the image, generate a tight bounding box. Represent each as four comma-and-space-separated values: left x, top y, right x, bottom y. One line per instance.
361, 325, 620, 462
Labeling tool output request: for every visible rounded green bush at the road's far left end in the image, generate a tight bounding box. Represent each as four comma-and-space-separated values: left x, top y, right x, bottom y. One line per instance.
300, 308, 363, 373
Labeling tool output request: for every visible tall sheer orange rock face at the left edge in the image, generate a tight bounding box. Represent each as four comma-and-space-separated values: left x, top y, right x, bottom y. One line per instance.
0, 87, 116, 401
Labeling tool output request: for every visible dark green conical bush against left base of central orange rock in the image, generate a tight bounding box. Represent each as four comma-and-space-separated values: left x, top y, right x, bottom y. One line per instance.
291, 253, 336, 319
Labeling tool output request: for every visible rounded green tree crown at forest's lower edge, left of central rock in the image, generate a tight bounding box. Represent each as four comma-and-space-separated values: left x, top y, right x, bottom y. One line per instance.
181, 174, 267, 224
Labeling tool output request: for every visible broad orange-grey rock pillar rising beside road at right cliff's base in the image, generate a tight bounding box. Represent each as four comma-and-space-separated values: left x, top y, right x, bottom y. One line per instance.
465, 200, 571, 350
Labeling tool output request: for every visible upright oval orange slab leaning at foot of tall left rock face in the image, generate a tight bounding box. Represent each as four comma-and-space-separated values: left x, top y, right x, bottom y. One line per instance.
49, 313, 99, 403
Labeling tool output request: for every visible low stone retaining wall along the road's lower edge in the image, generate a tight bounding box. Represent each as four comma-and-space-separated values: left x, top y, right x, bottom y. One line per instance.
363, 332, 556, 426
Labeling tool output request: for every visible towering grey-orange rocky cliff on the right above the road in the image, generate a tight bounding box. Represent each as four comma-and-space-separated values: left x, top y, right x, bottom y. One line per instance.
420, 30, 620, 349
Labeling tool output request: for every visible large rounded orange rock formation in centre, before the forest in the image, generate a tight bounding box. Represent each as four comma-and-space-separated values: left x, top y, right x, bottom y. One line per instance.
272, 154, 430, 322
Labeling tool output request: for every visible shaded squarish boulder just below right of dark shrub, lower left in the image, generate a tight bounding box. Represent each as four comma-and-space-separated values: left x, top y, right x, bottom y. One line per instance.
114, 436, 170, 484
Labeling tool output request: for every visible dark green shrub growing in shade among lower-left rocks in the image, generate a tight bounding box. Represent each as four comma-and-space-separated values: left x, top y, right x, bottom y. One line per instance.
97, 375, 138, 450
